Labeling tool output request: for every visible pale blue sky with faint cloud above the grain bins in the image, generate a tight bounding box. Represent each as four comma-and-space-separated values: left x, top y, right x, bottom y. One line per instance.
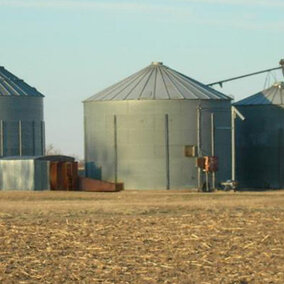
0, 0, 284, 159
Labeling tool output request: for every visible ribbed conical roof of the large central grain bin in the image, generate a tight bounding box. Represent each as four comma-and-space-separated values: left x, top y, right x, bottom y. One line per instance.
85, 62, 231, 102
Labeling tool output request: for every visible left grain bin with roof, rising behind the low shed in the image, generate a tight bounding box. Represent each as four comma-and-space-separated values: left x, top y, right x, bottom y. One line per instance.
0, 67, 45, 157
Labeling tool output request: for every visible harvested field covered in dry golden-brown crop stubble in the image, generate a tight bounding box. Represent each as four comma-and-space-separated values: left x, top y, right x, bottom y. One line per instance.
0, 191, 284, 284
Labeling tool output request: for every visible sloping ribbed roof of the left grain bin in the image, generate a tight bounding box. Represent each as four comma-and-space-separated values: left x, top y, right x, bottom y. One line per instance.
0, 66, 44, 97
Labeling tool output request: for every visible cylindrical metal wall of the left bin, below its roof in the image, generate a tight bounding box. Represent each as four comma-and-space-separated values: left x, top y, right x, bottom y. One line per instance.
0, 96, 45, 157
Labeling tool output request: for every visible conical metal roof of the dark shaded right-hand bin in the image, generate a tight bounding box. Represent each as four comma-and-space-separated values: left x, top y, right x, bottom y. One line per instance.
234, 82, 284, 106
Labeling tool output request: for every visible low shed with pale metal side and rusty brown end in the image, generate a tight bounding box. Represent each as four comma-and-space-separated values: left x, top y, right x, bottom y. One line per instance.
0, 156, 78, 190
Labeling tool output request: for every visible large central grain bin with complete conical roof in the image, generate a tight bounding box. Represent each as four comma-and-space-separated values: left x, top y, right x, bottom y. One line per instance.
84, 62, 231, 189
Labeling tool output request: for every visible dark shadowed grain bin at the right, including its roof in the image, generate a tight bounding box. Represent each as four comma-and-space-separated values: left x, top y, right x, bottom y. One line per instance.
235, 82, 284, 189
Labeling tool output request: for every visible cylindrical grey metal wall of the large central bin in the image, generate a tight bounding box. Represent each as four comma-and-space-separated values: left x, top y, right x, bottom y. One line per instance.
84, 100, 231, 189
